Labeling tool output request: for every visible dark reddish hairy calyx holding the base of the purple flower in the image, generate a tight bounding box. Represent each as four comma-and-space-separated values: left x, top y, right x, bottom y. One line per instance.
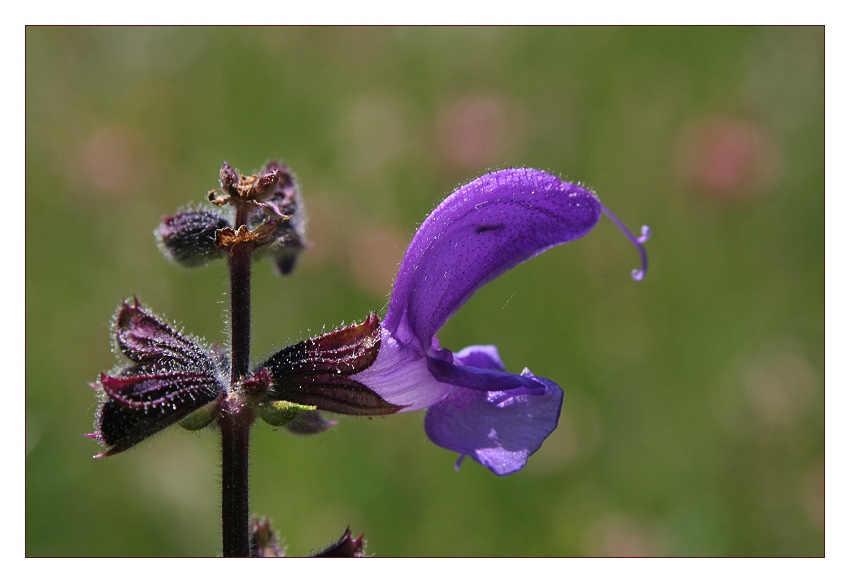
262, 313, 402, 415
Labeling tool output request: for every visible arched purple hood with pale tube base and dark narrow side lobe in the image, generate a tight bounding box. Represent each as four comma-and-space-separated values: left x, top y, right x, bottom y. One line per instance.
355, 168, 601, 410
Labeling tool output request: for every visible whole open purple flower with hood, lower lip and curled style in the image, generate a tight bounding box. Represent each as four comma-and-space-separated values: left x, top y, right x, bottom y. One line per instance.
351, 169, 649, 475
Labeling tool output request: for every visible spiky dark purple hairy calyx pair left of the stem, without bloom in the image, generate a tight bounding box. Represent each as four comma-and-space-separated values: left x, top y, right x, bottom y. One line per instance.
89, 299, 226, 457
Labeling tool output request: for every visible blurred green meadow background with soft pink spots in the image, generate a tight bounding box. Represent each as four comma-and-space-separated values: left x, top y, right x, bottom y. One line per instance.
26, 27, 824, 556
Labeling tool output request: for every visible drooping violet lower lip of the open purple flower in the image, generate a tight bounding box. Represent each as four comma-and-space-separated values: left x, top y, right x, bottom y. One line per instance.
425, 347, 564, 476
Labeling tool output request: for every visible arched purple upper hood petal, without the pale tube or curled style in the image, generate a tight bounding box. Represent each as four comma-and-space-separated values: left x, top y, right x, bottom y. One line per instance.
384, 168, 601, 354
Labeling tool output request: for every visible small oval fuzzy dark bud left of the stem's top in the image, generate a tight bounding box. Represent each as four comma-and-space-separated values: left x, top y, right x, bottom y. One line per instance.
154, 210, 230, 267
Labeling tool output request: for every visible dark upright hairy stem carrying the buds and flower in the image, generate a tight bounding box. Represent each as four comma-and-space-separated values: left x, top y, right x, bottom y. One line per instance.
219, 209, 254, 557
